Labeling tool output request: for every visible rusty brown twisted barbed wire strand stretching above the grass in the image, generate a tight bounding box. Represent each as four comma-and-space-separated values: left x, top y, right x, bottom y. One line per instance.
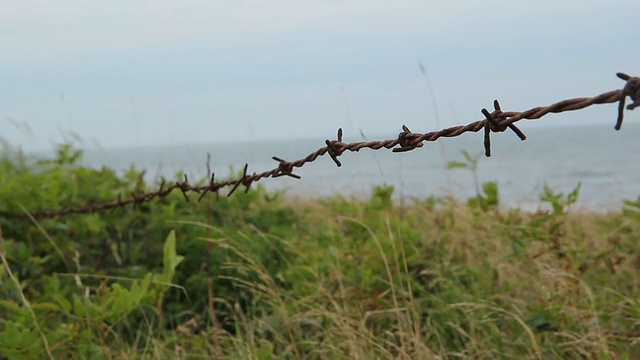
0, 73, 640, 218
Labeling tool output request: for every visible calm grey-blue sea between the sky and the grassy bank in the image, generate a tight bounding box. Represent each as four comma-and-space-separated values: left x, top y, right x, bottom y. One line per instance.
77, 121, 640, 209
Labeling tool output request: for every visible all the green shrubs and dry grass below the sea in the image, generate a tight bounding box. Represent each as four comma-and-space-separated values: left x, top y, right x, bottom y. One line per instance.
0, 145, 640, 359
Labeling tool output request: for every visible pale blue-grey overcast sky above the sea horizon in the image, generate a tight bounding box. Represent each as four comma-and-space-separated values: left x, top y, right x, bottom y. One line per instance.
0, 0, 640, 149
